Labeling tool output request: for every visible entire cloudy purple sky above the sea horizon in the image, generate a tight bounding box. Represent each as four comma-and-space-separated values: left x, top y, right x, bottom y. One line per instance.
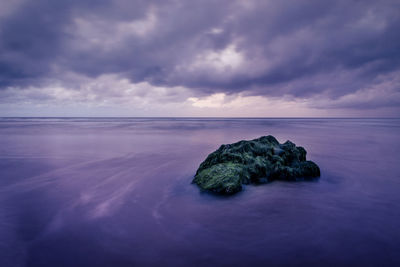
0, 0, 400, 117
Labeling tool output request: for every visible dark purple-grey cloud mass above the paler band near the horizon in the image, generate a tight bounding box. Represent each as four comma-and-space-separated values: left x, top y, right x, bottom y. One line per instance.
0, 0, 400, 109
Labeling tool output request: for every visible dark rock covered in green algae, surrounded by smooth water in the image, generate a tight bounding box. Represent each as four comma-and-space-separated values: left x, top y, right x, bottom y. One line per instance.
193, 135, 320, 194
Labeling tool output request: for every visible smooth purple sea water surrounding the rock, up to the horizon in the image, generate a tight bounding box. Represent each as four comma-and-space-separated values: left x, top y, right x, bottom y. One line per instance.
0, 118, 400, 266
